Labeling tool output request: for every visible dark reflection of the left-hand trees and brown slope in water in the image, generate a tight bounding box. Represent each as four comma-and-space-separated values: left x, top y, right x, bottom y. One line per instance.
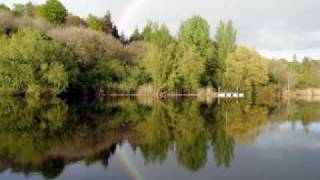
0, 98, 142, 178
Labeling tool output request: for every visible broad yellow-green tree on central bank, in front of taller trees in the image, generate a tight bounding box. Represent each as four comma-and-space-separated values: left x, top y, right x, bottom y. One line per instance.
141, 43, 204, 93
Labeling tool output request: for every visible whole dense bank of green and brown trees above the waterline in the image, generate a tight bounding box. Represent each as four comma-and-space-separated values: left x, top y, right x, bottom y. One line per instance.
0, 0, 320, 97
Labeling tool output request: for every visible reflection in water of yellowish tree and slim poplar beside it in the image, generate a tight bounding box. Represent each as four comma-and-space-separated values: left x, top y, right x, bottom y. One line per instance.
201, 101, 268, 168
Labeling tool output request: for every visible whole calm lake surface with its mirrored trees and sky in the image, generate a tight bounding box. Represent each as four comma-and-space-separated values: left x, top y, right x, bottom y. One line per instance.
0, 99, 320, 180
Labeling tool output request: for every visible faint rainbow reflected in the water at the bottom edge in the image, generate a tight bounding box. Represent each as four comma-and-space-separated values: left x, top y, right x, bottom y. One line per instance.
116, 148, 144, 180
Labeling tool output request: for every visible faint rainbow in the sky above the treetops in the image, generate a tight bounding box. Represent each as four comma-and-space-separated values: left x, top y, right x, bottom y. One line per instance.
116, 0, 147, 33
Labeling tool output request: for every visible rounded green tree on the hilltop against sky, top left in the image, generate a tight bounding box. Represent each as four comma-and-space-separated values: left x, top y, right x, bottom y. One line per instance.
38, 0, 68, 24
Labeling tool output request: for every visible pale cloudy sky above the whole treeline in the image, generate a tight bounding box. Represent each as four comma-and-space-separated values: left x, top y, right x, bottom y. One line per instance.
0, 0, 320, 59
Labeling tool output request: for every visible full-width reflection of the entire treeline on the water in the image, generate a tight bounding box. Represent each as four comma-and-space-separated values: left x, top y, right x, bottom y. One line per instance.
0, 98, 320, 178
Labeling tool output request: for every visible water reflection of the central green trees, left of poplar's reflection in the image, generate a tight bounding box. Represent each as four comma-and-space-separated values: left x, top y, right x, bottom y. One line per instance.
137, 101, 208, 170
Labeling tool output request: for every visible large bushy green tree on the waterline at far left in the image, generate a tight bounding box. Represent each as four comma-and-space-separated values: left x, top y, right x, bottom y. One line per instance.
0, 31, 70, 96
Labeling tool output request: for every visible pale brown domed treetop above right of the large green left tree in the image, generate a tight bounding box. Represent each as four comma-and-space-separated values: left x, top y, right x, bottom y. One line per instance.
48, 27, 123, 68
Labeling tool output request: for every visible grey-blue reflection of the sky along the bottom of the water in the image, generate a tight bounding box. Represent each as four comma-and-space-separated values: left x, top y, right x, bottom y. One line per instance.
0, 122, 320, 180
